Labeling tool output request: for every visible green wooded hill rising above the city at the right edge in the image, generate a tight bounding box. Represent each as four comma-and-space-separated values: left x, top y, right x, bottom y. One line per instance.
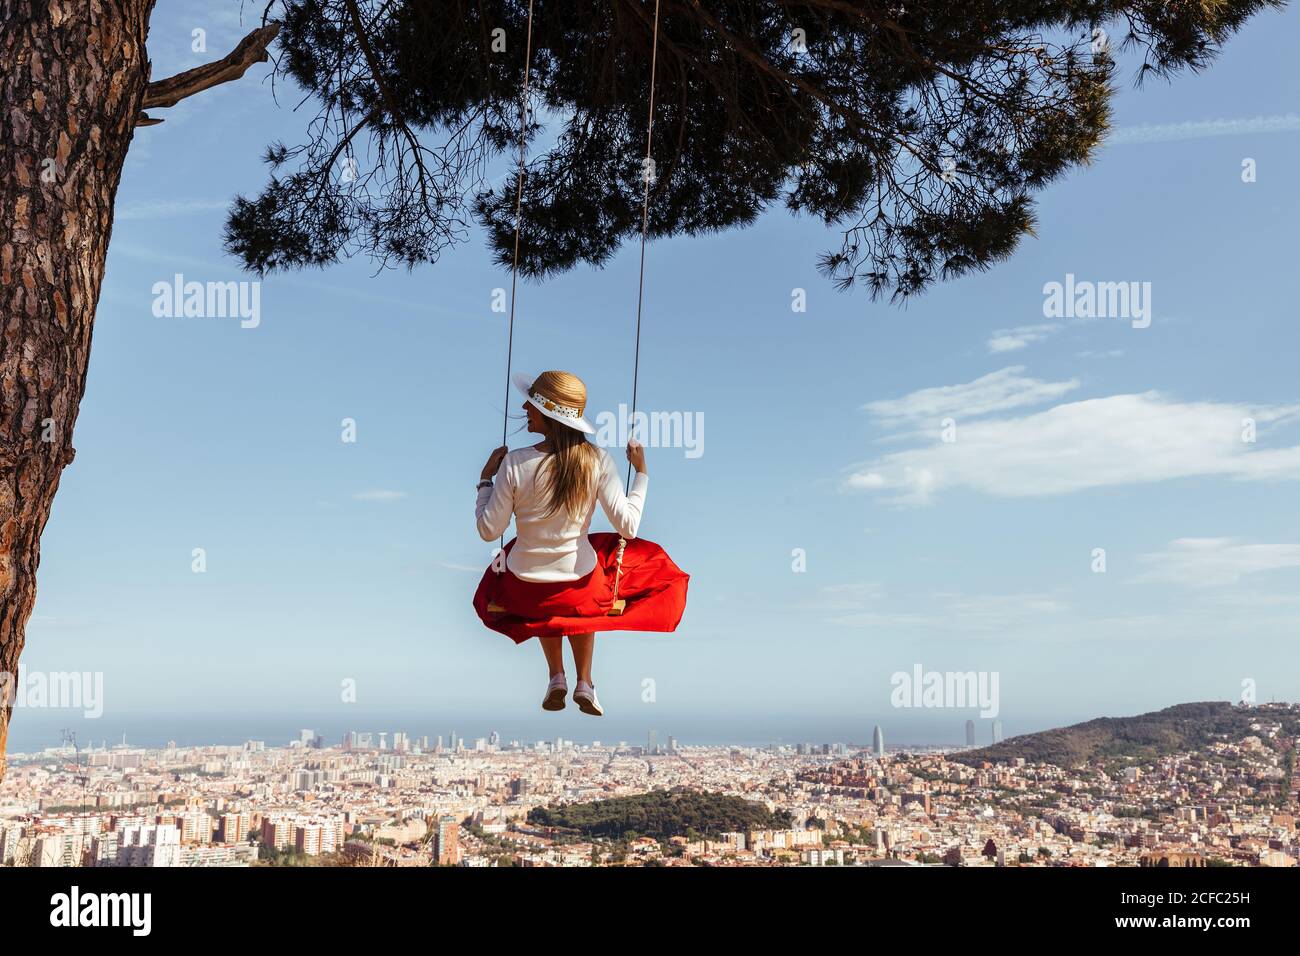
950, 701, 1300, 767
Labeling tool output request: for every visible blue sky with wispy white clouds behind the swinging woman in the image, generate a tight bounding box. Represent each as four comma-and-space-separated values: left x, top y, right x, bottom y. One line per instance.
10, 4, 1300, 749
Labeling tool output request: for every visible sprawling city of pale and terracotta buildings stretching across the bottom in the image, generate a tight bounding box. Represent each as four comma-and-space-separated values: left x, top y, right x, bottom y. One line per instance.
0, 702, 1300, 868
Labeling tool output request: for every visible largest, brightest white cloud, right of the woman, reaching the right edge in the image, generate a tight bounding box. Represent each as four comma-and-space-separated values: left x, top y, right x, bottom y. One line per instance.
846, 369, 1300, 505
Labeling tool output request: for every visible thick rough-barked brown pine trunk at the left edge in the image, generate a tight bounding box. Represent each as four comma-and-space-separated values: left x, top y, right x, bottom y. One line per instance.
0, 0, 155, 779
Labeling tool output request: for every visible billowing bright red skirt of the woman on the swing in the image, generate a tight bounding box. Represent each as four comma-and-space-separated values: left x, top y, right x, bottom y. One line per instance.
475, 532, 690, 644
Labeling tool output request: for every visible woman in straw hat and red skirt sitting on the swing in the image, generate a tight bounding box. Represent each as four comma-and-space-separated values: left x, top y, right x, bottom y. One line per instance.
475, 372, 689, 717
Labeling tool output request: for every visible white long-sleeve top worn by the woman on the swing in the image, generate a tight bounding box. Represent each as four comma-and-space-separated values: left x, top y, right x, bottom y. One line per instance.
475, 447, 650, 581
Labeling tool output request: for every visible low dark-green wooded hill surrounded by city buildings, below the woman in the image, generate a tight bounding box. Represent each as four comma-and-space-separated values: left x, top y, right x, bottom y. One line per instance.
528, 790, 790, 840
